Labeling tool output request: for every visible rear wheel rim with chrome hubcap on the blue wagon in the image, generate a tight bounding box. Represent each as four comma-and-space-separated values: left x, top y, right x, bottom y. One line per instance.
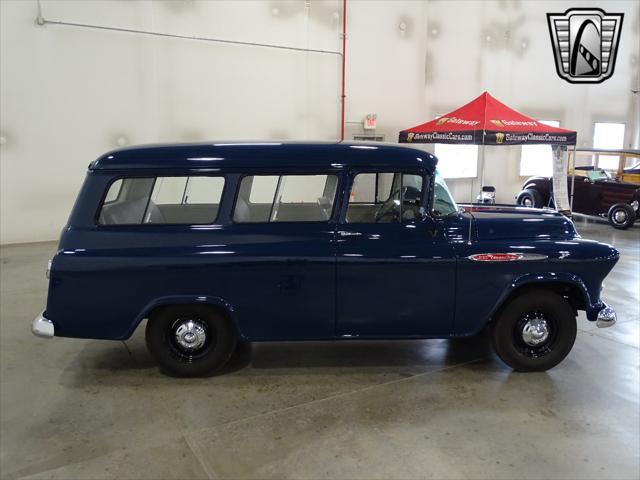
167, 318, 215, 363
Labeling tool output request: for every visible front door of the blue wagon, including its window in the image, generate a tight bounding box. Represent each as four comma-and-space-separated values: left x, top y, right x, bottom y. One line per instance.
336, 171, 456, 338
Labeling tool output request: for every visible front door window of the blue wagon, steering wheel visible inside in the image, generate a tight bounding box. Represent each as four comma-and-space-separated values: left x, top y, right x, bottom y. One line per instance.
347, 172, 423, 223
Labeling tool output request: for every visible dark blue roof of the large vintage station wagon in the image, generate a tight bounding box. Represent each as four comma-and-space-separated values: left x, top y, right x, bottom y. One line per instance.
89, 141, 437, 172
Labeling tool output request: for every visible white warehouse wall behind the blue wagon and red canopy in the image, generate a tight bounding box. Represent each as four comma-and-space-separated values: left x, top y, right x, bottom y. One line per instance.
0, 0, 640, 243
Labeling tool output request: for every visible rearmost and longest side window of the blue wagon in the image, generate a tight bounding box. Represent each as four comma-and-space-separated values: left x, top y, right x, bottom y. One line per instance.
98, 177, 224, 225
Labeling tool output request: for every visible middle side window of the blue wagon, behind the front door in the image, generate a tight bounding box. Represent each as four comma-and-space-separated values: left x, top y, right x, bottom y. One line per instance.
233, 175, 338, 223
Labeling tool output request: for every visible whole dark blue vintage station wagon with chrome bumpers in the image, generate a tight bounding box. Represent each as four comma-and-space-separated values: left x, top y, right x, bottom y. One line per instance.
32, 143, 618, 376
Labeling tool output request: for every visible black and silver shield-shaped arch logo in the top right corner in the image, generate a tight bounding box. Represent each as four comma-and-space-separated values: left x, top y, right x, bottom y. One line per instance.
547, 8, 624, 83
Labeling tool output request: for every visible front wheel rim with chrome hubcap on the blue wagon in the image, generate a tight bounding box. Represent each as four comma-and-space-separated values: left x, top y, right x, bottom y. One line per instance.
513, 310, 557, 358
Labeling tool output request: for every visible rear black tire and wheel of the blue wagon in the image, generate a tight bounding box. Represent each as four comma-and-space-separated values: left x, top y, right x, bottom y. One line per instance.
145, 305, 236, 377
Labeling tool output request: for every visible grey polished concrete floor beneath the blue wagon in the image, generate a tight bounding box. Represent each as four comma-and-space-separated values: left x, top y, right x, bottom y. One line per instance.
0, 219, 640, 479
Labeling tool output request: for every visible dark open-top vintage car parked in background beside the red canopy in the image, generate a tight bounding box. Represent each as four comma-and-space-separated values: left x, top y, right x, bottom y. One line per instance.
516, 167, 640, 229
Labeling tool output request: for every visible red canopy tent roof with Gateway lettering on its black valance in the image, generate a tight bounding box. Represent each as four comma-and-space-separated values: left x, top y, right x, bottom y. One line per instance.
399, 92, 576, 145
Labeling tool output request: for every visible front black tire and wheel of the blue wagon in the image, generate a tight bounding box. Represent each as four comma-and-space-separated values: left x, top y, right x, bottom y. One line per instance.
491, 289, 577, 372
